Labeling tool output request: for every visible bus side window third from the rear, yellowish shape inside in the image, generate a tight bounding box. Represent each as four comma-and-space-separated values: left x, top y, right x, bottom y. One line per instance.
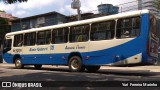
69, 25, 90, 42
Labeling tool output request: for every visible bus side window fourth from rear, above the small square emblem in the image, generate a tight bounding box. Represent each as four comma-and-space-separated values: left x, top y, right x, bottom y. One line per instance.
52, 28, 69, 44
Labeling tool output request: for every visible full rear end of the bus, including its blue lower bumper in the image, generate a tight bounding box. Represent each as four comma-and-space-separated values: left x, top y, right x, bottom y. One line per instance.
147, 15, 159, 64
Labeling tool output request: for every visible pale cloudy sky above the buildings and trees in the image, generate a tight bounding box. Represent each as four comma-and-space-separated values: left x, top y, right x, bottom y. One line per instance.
0, 0, 133, 18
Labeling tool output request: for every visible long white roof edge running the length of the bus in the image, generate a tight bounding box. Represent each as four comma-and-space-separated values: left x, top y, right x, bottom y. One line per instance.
6, 10, 149, 36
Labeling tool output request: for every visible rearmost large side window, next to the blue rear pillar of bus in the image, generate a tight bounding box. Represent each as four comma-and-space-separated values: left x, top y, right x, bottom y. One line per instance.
116, 17, 140, 39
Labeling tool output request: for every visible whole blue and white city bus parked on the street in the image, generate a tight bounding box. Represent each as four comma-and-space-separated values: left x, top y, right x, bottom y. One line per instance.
3, 10, 159, 72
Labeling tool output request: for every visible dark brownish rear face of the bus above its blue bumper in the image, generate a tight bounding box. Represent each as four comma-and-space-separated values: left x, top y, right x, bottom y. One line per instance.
149, 15, 159, 58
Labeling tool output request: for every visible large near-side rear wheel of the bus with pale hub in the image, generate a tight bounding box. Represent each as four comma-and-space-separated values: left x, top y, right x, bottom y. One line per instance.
68, 56, 85, 72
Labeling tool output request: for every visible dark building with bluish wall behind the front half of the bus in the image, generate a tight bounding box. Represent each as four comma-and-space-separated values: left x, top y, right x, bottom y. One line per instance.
11, 12, 67, 32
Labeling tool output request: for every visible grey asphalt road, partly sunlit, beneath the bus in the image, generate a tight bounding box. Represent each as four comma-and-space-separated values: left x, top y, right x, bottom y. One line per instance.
0, 64, 160, 90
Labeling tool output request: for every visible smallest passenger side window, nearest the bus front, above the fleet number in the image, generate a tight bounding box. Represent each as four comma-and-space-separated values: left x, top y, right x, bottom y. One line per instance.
13, 34, 23, 47
